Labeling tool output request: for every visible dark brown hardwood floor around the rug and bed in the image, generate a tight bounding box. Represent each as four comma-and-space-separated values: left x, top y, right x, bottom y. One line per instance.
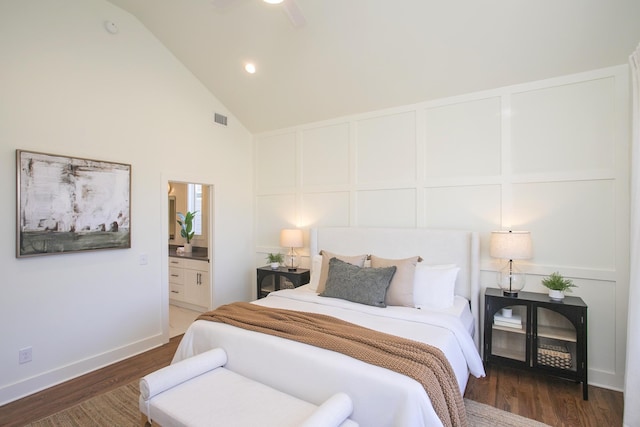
0, 336, 623, 427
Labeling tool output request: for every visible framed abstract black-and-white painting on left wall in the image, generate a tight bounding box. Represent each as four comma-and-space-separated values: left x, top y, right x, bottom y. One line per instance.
16, 150, 131, 258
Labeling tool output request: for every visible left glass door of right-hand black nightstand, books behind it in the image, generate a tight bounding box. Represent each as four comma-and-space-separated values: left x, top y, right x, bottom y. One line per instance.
491, 305, 529, 362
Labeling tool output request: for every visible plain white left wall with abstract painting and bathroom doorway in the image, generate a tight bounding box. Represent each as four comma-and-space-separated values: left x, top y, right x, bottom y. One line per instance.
0, 0, 253, 404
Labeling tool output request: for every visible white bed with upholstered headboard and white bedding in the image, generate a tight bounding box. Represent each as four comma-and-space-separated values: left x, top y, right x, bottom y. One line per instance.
174, 228, 485, 426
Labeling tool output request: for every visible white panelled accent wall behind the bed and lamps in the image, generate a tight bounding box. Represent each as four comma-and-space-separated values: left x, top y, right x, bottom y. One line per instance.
255, 66, 629, 389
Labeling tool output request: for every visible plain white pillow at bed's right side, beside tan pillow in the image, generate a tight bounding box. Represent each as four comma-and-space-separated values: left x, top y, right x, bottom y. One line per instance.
413, 263, 460, 309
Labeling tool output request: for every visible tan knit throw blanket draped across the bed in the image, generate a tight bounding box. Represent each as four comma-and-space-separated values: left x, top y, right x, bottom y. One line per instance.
198, 302, 467, 426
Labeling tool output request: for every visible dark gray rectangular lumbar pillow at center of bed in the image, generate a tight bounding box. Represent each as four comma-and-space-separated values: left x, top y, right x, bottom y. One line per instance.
320, 258, 396, 307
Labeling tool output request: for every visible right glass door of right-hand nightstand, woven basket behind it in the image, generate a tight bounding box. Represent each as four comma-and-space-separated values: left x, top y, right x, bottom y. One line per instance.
534, 307, 578, 371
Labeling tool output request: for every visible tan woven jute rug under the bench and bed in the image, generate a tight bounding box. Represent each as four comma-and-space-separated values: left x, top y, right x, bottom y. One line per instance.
28, 381, 546, 427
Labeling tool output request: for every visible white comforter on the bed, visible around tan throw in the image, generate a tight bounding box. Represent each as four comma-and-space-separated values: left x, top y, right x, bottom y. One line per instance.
173, 287, 485, 427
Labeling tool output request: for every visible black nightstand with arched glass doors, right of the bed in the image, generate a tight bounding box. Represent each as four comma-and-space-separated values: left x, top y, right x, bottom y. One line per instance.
484, 288, 589, 400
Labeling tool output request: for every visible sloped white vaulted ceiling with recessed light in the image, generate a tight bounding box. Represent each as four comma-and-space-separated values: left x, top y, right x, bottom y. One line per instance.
110, 0, 640, 133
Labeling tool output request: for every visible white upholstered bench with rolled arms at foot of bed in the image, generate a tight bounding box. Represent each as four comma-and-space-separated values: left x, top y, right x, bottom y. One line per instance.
139, 348, 358, 427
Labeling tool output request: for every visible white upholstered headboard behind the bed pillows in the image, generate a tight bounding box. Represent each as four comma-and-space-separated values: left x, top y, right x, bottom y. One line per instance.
309, 227, 480, 346
